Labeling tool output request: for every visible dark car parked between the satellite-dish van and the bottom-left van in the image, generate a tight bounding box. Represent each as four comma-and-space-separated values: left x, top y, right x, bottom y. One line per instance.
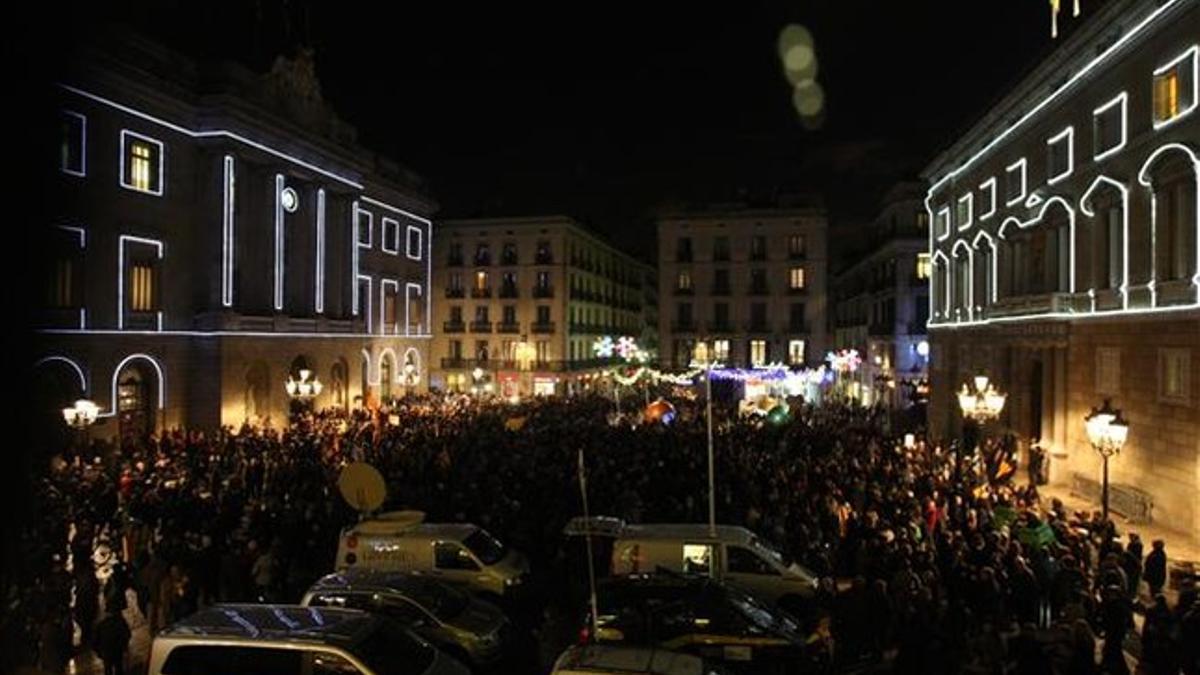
300, 569, 511, 664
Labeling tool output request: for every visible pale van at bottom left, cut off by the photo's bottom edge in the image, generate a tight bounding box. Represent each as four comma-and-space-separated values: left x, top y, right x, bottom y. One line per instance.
149, 604, 470, 675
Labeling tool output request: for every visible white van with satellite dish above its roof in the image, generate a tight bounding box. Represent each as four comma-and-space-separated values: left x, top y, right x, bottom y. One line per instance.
337, 510, 529, 596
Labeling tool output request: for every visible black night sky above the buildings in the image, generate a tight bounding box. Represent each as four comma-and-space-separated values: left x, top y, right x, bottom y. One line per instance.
56, 0, 1097, 253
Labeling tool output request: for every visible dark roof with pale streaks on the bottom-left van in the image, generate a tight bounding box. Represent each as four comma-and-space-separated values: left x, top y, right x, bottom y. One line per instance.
157, 604, 379, 645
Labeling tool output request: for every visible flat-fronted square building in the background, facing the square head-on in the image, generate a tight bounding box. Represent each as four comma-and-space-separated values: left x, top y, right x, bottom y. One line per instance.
659, 205, 828, 369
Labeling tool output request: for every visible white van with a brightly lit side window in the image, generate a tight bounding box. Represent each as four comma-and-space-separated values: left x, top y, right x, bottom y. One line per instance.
563, 516, 817, 610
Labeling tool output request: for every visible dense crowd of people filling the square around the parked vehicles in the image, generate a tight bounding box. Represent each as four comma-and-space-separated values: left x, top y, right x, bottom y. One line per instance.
0, 390, 1200, 674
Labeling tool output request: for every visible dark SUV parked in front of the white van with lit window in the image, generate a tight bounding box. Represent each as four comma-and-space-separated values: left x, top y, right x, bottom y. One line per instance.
581, 574, 828, 673
